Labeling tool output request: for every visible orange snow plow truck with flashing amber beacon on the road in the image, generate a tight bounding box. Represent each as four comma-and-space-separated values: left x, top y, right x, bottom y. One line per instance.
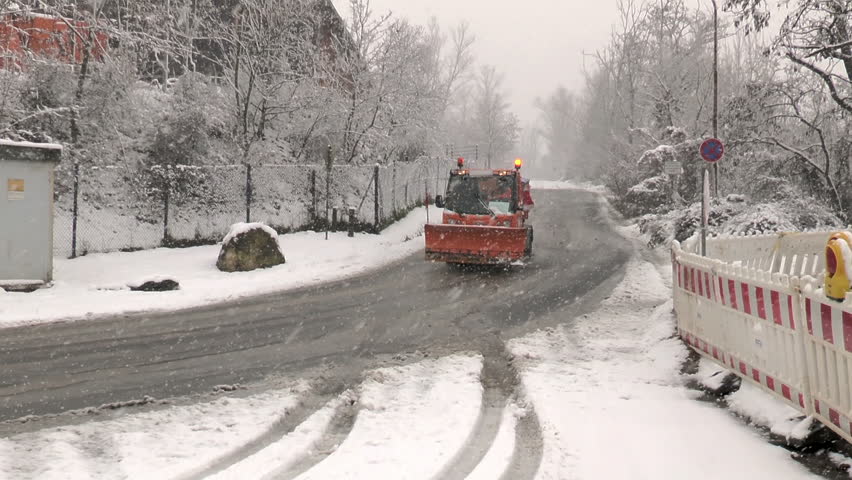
426, 158, 533, 265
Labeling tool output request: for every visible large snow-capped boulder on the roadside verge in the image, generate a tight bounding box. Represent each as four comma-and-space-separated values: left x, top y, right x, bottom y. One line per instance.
216, 223, 286, 272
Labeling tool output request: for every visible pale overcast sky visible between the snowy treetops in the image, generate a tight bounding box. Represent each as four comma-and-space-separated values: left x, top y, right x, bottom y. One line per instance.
333, 0, 616, 125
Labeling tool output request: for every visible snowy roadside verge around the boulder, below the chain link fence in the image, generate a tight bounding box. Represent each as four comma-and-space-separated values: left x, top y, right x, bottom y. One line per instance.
0, 204, 441, 327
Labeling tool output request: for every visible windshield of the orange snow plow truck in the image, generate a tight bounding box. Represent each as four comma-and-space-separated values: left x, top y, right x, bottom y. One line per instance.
445, 175, 516, 215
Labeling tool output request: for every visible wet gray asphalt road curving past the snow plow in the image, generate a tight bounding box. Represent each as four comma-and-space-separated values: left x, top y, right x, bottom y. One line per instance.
0, 191, 630, 421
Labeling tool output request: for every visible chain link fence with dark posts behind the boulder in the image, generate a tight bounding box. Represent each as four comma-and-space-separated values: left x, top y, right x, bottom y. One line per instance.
53, 157, 453, 257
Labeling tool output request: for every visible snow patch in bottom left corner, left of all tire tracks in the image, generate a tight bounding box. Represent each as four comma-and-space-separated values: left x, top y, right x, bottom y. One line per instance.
0, 385, 306, 480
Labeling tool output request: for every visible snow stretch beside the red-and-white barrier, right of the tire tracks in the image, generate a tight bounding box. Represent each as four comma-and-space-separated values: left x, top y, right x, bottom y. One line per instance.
509, 255, 816, 480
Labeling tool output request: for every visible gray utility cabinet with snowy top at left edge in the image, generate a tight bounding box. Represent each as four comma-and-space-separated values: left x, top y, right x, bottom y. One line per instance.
0, 140, 62, 289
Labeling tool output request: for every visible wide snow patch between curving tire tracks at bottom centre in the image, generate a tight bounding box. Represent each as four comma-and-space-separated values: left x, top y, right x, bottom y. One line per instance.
298, 355, 482, 480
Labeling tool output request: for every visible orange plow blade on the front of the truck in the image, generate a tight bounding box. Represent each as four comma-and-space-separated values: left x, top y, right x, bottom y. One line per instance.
426, 225, 527, 264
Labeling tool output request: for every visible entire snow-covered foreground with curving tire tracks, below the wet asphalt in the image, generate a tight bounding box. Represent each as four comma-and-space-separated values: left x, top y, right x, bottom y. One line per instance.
0, 185, 828, 480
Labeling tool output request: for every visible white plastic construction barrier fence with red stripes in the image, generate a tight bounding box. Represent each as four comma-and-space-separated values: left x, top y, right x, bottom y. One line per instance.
672, 232, 852, 442
